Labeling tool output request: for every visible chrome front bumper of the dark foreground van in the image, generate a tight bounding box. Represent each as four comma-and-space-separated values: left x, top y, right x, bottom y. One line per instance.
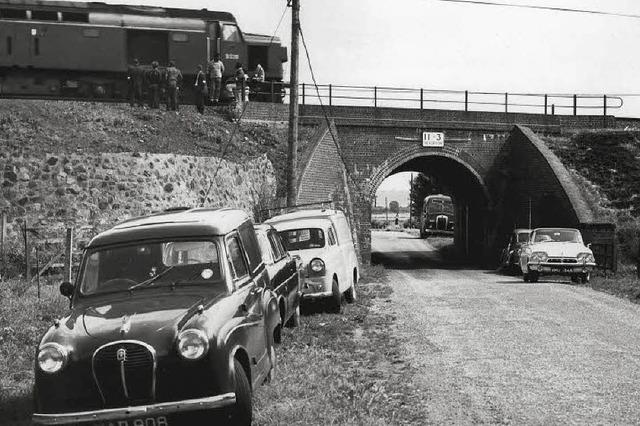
32, 392, 236, 425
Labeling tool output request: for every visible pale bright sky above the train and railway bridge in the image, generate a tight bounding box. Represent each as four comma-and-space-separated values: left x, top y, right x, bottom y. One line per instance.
82, 0, 640, 195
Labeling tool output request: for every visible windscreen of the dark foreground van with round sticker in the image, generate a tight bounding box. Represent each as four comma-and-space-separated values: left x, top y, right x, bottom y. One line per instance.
80, 240, 226, 295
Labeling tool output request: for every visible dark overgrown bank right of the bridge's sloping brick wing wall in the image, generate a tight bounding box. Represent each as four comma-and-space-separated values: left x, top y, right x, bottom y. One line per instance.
545, 130, 640, 263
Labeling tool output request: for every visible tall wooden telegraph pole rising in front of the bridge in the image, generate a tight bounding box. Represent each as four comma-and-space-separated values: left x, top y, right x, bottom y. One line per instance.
287, 0, 300, 207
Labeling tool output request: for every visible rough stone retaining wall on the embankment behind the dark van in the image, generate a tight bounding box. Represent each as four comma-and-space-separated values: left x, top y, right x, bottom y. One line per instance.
0, 152, 276, 272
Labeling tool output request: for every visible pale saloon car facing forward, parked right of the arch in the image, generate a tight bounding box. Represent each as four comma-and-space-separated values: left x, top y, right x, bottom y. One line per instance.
520, 228, 596, 283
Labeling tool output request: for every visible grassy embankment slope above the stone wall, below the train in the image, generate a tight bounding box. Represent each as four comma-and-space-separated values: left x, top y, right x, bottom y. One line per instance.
0, 100, 315, 195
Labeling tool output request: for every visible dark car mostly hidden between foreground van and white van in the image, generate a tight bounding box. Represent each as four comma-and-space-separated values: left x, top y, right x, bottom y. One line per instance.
253, 224, 302, 343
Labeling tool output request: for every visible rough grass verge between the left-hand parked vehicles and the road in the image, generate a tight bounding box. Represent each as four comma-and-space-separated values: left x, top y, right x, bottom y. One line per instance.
255, 266, 423, 425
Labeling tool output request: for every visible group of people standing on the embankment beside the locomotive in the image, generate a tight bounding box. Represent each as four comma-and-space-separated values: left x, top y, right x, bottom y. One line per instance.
127, 54, 265, 114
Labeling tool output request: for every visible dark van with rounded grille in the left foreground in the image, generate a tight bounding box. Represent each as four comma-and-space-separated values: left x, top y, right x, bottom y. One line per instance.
33, 209, 280, 426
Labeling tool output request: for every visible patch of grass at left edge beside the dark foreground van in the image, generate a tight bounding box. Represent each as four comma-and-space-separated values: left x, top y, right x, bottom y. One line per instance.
0, 280, 68, 425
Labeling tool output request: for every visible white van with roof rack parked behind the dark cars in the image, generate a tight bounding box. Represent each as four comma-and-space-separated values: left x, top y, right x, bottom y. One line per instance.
266, 209, 360, 312
